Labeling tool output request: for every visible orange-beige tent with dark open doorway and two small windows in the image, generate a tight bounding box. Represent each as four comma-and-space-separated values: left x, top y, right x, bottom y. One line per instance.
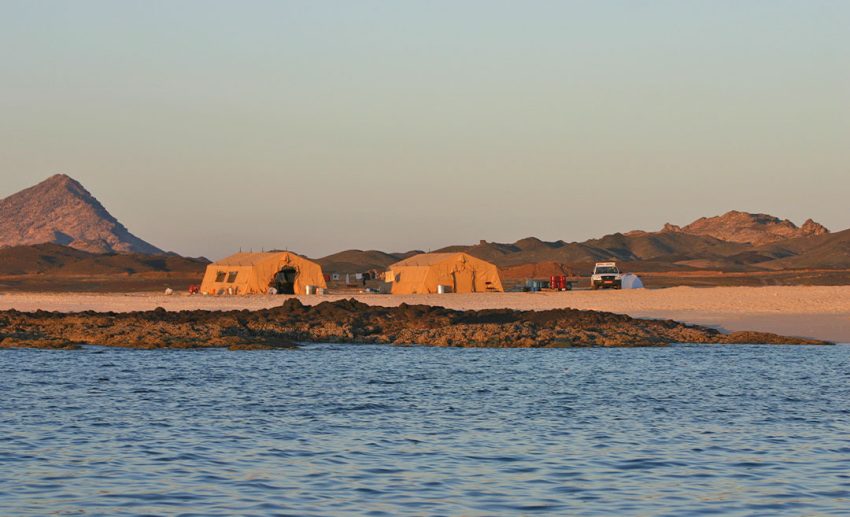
201, 252, 327, 294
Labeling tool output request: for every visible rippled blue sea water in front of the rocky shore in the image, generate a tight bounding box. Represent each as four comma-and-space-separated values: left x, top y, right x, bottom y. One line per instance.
0, 345, 850, 515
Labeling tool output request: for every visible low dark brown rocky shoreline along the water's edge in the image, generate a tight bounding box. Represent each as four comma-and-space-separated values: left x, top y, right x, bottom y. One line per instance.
0, 299, 830, 350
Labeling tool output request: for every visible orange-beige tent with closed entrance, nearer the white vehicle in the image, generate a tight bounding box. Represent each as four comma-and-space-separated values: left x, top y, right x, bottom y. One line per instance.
386, 253, 503, 294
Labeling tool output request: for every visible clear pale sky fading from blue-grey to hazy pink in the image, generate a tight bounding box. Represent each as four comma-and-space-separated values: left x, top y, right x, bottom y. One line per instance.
0, 0, 850, 258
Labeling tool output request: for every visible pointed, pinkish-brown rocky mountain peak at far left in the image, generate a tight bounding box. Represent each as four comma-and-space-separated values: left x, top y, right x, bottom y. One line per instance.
0, 174, 163, 255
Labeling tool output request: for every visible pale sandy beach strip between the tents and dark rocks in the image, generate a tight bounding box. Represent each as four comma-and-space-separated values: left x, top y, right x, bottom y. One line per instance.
0, 286, 850, 343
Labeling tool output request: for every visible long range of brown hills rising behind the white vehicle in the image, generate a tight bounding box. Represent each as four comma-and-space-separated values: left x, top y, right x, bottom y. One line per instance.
430, 211, 850, 272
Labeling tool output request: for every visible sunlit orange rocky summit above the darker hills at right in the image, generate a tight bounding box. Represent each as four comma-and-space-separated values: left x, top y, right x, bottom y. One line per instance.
661, 210, 829, 246
